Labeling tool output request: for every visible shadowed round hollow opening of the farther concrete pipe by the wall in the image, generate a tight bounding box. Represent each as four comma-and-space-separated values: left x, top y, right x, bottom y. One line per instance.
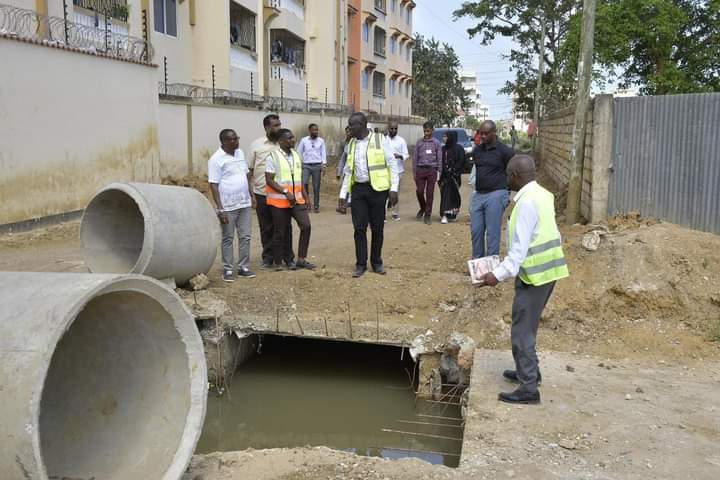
80, 190, 145, 273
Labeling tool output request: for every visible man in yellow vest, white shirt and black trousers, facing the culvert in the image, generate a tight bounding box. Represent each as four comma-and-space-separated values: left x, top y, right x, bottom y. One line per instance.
337, 112, 399, 278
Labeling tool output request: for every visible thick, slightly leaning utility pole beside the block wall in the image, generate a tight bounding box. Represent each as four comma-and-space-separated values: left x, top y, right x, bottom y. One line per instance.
566, 0, 595, 224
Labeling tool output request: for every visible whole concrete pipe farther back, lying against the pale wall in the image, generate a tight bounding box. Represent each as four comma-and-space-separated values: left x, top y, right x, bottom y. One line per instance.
80, 183, 220, 285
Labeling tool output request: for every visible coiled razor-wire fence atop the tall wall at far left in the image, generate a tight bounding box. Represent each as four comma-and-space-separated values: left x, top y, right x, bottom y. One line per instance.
0, 4, 154, 63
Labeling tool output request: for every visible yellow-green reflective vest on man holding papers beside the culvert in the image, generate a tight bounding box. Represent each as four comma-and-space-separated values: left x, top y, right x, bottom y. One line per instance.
508, 183, 570, 286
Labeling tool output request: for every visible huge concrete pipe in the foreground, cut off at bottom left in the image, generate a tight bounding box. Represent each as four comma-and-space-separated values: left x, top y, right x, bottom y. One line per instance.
0, 272, 207, 480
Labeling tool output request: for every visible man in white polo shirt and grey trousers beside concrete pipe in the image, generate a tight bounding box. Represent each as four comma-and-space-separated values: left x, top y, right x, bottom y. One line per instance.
208, 129, 255, 282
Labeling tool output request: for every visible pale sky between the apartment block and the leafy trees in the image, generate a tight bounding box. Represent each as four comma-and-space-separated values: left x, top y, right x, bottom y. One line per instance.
413, 0, 515, 120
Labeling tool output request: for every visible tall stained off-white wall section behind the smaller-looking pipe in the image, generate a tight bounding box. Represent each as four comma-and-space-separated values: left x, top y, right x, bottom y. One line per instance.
0, 38, 159, 224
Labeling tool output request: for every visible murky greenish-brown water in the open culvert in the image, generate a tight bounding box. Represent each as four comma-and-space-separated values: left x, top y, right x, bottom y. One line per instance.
197, 336, 463, 466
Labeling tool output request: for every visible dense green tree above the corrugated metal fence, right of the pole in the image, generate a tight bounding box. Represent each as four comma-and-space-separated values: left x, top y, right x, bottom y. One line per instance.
584, 0, 720, 95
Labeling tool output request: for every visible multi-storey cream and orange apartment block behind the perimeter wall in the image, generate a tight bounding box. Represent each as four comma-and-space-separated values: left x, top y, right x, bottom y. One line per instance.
7, 0, 415, 111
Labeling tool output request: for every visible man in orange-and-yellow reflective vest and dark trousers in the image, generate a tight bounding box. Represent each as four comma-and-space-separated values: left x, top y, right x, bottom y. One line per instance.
265, 129, 315, 271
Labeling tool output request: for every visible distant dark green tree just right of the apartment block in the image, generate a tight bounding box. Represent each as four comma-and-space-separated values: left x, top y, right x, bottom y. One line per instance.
412, 35, 469, 125
